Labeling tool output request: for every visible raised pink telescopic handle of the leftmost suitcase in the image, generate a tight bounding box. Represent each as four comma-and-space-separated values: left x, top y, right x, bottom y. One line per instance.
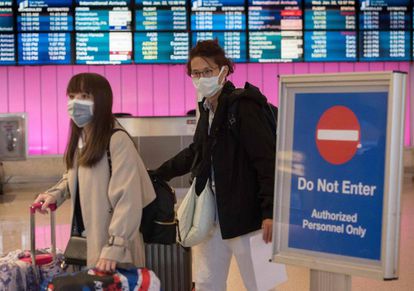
29, 202, 57, 266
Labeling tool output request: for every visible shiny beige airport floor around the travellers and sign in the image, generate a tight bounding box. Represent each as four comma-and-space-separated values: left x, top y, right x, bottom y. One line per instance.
0, 177, 414, 291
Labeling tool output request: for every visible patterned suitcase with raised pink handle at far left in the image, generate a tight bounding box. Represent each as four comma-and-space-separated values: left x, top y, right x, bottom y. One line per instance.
0, 203, 63, 291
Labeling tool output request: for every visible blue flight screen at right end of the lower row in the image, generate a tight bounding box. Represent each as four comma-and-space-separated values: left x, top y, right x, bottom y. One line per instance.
359, 30, 410, 61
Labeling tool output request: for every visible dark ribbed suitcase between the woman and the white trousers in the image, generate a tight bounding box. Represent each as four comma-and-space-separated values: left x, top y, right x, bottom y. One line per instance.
145, 243, 193, 291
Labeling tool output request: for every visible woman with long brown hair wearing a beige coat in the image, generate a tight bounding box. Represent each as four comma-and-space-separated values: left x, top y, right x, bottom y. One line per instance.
35, 73, 155, 271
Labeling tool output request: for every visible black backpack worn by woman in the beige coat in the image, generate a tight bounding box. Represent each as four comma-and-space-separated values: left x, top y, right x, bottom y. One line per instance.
106, 128, 177, 244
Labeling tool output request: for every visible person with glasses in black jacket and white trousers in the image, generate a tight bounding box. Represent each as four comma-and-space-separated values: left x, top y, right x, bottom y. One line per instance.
155, 40, 275, 291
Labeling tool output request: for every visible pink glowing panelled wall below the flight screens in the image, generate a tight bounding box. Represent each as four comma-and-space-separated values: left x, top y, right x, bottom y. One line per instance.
0, 62, 411, 155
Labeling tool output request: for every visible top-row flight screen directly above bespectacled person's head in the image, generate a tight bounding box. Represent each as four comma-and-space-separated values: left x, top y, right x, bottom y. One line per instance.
191, 0, 246, 31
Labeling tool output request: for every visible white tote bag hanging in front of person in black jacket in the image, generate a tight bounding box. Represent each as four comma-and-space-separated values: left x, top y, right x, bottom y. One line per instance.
177, 179, 216, 247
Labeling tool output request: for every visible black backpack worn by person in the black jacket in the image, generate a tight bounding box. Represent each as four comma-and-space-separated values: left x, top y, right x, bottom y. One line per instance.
227, 82, 278, 141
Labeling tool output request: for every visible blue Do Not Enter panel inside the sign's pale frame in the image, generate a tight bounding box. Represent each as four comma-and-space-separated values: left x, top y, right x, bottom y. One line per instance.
288, 92, 388, 261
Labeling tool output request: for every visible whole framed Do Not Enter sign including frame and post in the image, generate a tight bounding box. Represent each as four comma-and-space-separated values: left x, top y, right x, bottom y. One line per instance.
273, 72, 406, 291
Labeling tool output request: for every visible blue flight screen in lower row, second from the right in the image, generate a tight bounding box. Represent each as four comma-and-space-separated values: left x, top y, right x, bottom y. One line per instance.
305, 30, 358, 62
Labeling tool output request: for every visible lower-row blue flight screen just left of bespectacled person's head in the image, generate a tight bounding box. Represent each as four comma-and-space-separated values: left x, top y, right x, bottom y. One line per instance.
134, 32, 190, 63
